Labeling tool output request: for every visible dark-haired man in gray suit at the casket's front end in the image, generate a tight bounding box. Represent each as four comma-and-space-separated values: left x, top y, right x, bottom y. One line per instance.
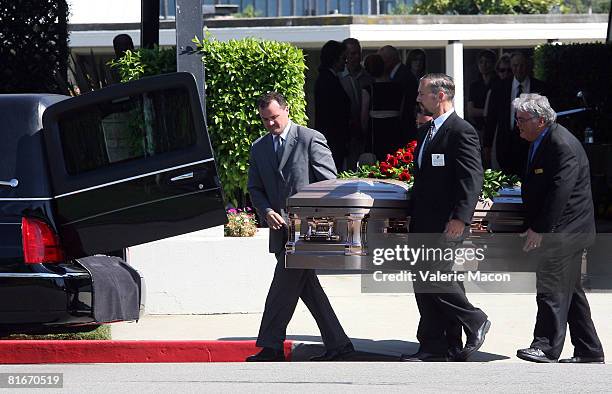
247, 92, 354, 361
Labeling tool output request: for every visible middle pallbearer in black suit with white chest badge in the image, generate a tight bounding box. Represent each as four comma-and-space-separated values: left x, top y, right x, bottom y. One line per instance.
402, 74, 491, 361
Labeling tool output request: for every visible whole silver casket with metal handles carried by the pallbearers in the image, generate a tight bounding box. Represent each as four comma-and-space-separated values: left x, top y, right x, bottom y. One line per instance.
286, 179, 523, 271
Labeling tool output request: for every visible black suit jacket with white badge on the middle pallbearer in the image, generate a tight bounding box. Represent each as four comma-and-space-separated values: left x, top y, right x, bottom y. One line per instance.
410, 112, 483, 233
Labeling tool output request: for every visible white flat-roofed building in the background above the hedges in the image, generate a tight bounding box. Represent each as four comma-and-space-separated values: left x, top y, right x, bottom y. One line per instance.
69, 0, 608, 117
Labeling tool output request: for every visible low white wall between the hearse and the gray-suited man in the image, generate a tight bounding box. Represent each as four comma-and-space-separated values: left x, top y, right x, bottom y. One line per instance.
129, 226, 276, 314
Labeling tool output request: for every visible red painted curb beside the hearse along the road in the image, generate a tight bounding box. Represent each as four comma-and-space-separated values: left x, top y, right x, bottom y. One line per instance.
0, 340, 293, 364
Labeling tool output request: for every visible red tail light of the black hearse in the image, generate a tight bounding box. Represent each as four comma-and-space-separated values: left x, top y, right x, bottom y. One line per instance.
21, 217, 64, 264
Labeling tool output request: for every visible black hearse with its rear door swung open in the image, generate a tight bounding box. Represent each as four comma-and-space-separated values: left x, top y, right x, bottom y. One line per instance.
0, 73, 226, 335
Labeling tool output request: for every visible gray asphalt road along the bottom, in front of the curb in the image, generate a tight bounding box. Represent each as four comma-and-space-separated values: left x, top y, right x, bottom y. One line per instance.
0, 362, 612, 394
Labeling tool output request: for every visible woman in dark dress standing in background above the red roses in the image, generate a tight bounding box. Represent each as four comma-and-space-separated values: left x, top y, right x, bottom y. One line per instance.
361, 55, 406, 160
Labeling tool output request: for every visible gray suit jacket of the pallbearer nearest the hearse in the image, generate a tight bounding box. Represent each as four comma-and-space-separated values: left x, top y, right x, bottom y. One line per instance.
247, 123, 336, 253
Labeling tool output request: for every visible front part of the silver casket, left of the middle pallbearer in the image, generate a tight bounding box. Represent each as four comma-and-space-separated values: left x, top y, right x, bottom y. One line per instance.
286, 179, 409, 270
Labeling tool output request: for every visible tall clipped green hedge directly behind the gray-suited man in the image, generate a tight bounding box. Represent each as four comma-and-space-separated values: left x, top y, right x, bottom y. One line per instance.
194, 37, 306, 206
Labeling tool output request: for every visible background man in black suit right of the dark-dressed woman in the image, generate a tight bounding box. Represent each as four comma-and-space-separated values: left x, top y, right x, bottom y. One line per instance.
378, 45, 419, 141
